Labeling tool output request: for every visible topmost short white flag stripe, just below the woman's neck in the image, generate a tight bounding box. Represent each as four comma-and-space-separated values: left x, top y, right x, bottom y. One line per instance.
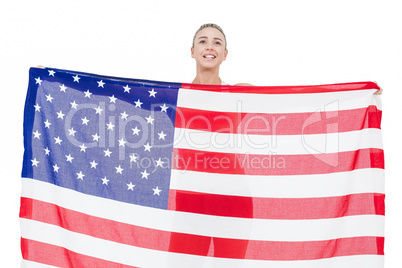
177, 88, 379, 113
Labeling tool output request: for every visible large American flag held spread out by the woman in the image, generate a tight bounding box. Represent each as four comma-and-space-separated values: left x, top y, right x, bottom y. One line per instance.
20, 68, 384, 268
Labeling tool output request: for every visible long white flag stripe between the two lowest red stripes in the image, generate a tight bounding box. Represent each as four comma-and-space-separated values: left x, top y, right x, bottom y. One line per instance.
21, 219, 384, 268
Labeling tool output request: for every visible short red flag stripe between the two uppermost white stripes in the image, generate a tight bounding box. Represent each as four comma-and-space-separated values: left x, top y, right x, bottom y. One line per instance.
175, 106, 382, 135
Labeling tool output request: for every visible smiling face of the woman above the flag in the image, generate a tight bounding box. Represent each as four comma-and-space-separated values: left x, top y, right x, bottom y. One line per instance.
191, 27, 228, 69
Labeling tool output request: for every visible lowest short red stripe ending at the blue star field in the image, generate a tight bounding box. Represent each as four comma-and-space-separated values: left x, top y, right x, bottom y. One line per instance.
168, 190, 385, 220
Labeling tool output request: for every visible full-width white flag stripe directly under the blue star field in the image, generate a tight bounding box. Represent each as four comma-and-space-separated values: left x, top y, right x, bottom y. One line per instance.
22, 179, 384, 241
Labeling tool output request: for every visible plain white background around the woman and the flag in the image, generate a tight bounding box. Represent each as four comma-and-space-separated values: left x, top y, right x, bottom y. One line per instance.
0, 0, 402, 268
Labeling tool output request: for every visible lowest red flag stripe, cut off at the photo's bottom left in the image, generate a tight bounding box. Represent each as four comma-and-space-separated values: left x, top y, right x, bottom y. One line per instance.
21, 238, 134, 268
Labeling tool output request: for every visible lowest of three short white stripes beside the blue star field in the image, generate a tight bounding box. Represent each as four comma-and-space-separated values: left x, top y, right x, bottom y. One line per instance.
170, 168, 385, 198
